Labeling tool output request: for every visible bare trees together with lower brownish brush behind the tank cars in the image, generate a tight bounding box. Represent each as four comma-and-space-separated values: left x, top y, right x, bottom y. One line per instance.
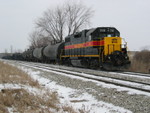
29, 2, 93, 49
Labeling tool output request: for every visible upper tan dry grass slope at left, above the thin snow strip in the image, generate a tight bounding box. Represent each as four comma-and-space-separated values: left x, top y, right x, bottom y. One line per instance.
0, 62, 39, 87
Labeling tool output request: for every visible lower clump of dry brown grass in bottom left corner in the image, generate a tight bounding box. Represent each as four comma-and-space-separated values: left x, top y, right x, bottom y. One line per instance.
0, 89, 60, 113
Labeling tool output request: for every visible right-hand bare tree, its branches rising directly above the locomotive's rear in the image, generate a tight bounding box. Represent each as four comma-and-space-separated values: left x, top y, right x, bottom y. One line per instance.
65, 2, 93, 35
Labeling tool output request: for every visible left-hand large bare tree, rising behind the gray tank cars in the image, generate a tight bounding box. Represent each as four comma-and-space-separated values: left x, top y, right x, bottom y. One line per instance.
36, 8, 65, 42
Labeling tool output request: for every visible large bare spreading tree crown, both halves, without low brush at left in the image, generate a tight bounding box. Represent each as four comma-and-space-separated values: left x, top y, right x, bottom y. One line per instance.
36, 2, 93, 42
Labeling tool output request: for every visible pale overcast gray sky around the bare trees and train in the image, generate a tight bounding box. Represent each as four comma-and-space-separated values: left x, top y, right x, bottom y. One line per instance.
0, 0, 150, 52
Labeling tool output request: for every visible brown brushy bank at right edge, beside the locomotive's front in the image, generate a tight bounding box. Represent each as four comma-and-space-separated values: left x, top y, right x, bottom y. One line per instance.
130, 50, 150, 73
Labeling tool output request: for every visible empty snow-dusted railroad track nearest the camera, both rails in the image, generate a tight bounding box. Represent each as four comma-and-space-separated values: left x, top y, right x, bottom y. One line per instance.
16, 63, 150, 93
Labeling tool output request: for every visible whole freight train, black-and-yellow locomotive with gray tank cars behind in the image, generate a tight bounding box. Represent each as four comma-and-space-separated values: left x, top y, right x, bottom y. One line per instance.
2, 27, 130, 70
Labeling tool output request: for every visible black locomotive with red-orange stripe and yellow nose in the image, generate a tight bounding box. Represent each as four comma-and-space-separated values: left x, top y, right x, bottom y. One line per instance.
61, 27, 130, 70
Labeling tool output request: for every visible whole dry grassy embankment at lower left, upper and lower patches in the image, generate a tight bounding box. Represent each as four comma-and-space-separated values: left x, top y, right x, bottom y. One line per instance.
0, 61, 84, 113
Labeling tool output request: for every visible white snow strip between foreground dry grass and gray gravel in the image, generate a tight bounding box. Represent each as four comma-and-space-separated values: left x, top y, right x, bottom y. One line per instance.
22, 67, 132, 113
